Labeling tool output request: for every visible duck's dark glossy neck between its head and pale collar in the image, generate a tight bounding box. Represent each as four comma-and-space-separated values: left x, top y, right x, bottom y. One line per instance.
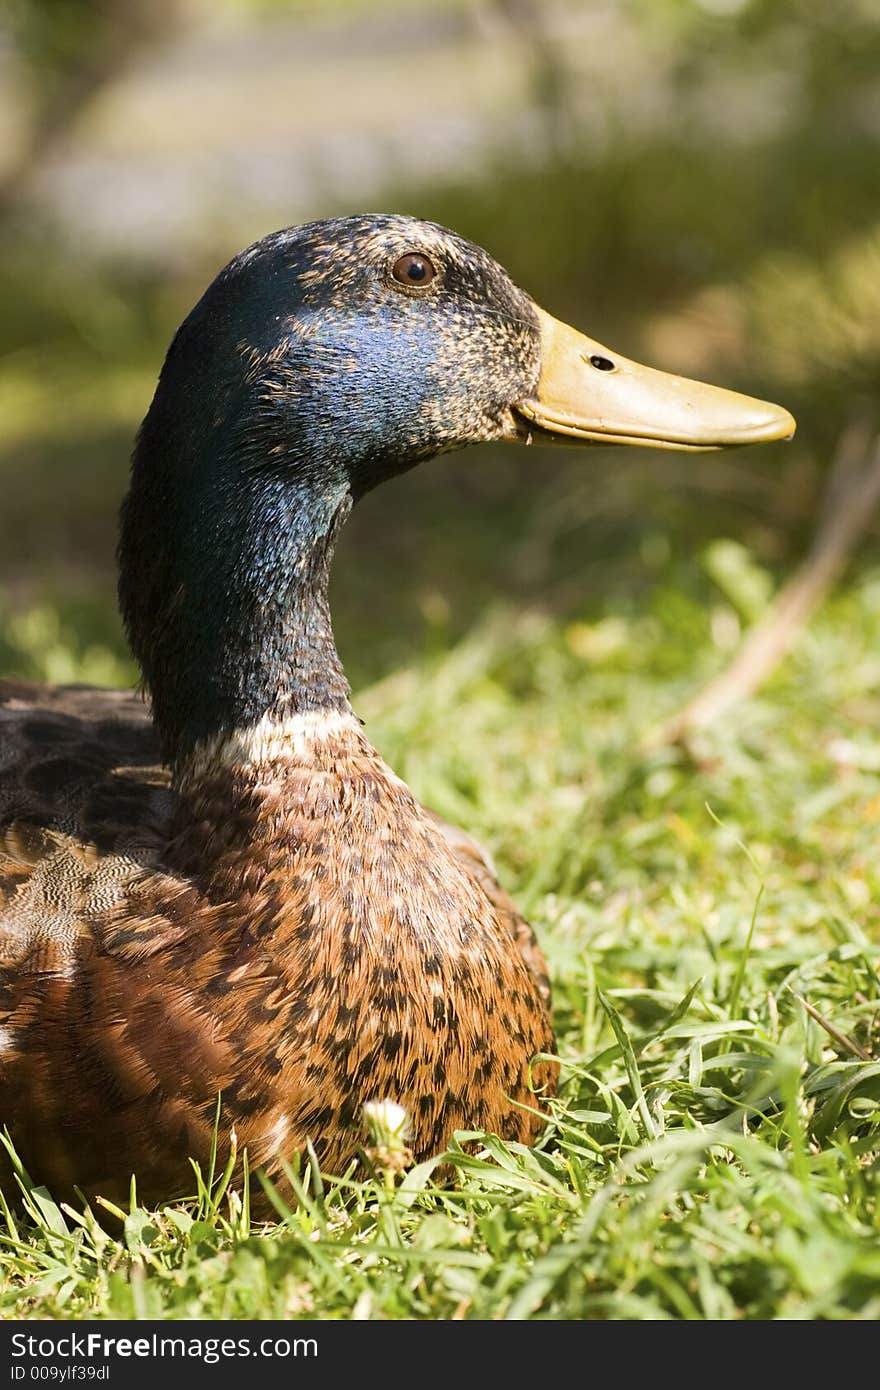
120, 473, 352, 766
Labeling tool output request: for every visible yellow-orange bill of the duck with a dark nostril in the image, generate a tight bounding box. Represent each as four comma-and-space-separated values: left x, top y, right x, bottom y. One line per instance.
514, 309, 797, 449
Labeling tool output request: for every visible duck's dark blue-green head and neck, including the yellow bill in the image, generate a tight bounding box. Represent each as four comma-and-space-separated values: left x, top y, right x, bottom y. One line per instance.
120, 215, 795, 753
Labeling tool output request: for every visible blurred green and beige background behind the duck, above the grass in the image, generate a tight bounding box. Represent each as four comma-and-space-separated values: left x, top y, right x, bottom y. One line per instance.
0, 0, 880, 688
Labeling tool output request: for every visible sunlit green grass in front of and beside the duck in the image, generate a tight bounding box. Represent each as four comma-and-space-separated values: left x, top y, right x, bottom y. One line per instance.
0, 553, 880, 1319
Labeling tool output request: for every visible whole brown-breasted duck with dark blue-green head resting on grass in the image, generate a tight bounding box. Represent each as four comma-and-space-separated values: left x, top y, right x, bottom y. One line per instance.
0, 214, 794, 1204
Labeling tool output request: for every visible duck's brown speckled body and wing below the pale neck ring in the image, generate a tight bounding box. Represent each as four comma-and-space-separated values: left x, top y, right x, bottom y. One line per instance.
0, 682, 556, 1201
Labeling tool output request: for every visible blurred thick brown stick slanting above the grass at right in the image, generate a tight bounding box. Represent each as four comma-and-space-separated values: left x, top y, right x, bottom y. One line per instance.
644, 423, 880, 751
